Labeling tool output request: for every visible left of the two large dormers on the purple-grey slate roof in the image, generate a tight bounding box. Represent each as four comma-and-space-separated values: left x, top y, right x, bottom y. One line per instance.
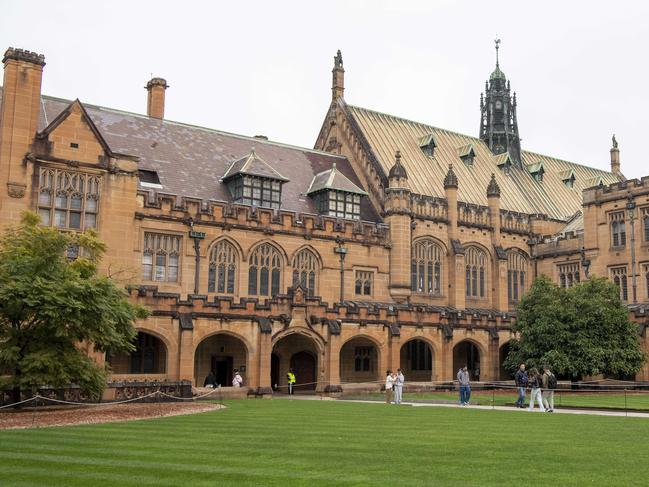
221, 148, 289, 208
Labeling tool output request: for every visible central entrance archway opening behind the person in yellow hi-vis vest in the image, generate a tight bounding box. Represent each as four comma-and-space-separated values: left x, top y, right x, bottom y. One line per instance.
271, 333, 320, 393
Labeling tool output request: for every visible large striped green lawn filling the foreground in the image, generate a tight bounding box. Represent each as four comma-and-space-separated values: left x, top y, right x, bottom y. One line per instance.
0, 399, 649, 487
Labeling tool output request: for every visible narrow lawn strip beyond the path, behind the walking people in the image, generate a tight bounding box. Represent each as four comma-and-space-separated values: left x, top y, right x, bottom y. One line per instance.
344, 390, 649, 410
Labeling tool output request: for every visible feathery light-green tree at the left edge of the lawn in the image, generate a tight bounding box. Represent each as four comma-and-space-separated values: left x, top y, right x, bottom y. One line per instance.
0, 212, 148, 401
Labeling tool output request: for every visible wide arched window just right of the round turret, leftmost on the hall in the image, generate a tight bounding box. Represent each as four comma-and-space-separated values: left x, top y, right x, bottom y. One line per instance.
410, 239, 443, 296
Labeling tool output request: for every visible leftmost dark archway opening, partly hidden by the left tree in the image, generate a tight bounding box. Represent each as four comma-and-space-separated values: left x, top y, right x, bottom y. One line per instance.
106, 331, 167, 375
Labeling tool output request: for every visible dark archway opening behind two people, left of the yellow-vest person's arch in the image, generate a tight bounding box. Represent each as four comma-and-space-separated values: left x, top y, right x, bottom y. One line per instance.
194, 333, 249, 387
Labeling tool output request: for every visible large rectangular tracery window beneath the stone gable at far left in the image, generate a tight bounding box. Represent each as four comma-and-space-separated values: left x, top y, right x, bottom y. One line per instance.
38, 168, 101, 230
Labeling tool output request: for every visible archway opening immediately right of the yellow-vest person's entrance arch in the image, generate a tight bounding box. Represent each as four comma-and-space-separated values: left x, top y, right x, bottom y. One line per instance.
340, 337, 383, 383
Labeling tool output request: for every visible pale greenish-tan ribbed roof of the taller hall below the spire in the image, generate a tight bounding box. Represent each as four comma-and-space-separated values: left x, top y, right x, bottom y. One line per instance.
338, 100, 618, 219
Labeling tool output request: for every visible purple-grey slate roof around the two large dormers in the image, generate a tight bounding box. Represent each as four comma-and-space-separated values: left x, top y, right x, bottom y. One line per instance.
0, 88, 381, 222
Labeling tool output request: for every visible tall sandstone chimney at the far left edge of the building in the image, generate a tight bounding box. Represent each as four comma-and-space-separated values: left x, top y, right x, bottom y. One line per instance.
0, 47, 45, 208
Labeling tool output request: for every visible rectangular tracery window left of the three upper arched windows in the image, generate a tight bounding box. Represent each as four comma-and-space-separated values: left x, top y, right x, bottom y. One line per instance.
142, 232, 182, 282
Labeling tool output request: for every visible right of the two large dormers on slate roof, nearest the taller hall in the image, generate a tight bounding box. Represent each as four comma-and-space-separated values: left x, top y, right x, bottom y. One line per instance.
306, 163, 367, 220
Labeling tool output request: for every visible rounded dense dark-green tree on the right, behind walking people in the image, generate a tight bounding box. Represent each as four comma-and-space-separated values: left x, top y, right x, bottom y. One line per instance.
504, 276, 645, 379
